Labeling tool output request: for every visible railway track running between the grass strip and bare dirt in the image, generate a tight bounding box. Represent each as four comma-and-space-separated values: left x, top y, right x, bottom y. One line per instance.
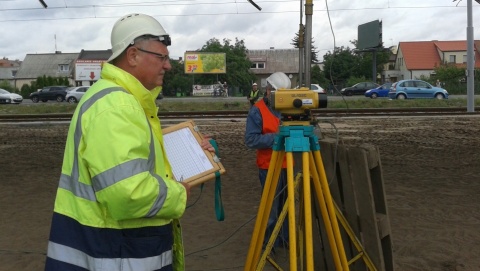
0, 107, 480, 123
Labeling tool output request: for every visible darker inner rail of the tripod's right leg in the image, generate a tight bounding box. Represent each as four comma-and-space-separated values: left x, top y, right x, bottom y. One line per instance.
310, 153, 348, 270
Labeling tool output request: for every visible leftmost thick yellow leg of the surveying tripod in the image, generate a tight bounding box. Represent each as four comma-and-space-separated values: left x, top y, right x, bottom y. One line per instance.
244, 151, 285, 271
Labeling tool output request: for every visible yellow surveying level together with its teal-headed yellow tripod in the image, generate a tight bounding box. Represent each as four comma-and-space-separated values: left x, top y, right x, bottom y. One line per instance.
244, 100, 375, 271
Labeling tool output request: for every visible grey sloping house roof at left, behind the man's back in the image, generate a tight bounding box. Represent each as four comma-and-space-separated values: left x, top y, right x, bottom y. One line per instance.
15, 53, 79, 79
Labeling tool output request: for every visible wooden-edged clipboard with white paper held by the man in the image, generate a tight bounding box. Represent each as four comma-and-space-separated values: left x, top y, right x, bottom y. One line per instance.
162, 120, 225, 186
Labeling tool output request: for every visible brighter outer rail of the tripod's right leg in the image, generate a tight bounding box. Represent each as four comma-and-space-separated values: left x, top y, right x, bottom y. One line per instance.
311, 150, 349, 270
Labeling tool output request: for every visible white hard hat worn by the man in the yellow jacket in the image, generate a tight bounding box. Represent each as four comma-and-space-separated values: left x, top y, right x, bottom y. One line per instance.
108, 13, 171, 62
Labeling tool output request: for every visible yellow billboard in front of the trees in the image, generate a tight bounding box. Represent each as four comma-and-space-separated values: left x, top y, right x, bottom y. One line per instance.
184, 52, 227, 74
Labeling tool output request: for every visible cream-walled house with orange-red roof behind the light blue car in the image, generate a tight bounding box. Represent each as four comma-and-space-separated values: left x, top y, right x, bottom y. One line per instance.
385, 40, 480, 82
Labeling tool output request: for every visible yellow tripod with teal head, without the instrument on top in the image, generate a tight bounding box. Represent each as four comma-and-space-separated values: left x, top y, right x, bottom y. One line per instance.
244, 121, 349, 271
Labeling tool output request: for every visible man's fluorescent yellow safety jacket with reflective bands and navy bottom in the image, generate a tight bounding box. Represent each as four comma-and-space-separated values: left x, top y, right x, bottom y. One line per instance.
46, 63, 187, 270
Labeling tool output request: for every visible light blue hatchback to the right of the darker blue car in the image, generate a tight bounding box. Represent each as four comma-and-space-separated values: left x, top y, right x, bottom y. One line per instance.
388, 79, 448, 99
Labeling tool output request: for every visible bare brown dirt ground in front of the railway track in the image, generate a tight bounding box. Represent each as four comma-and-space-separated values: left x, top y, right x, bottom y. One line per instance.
0, 116, 480, 271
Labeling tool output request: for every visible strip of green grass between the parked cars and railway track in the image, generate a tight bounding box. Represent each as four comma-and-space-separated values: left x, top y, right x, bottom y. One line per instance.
0, 97, 480, 114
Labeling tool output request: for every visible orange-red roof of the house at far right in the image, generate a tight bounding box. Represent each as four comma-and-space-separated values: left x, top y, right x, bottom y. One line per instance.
399, 40, 480, 70
